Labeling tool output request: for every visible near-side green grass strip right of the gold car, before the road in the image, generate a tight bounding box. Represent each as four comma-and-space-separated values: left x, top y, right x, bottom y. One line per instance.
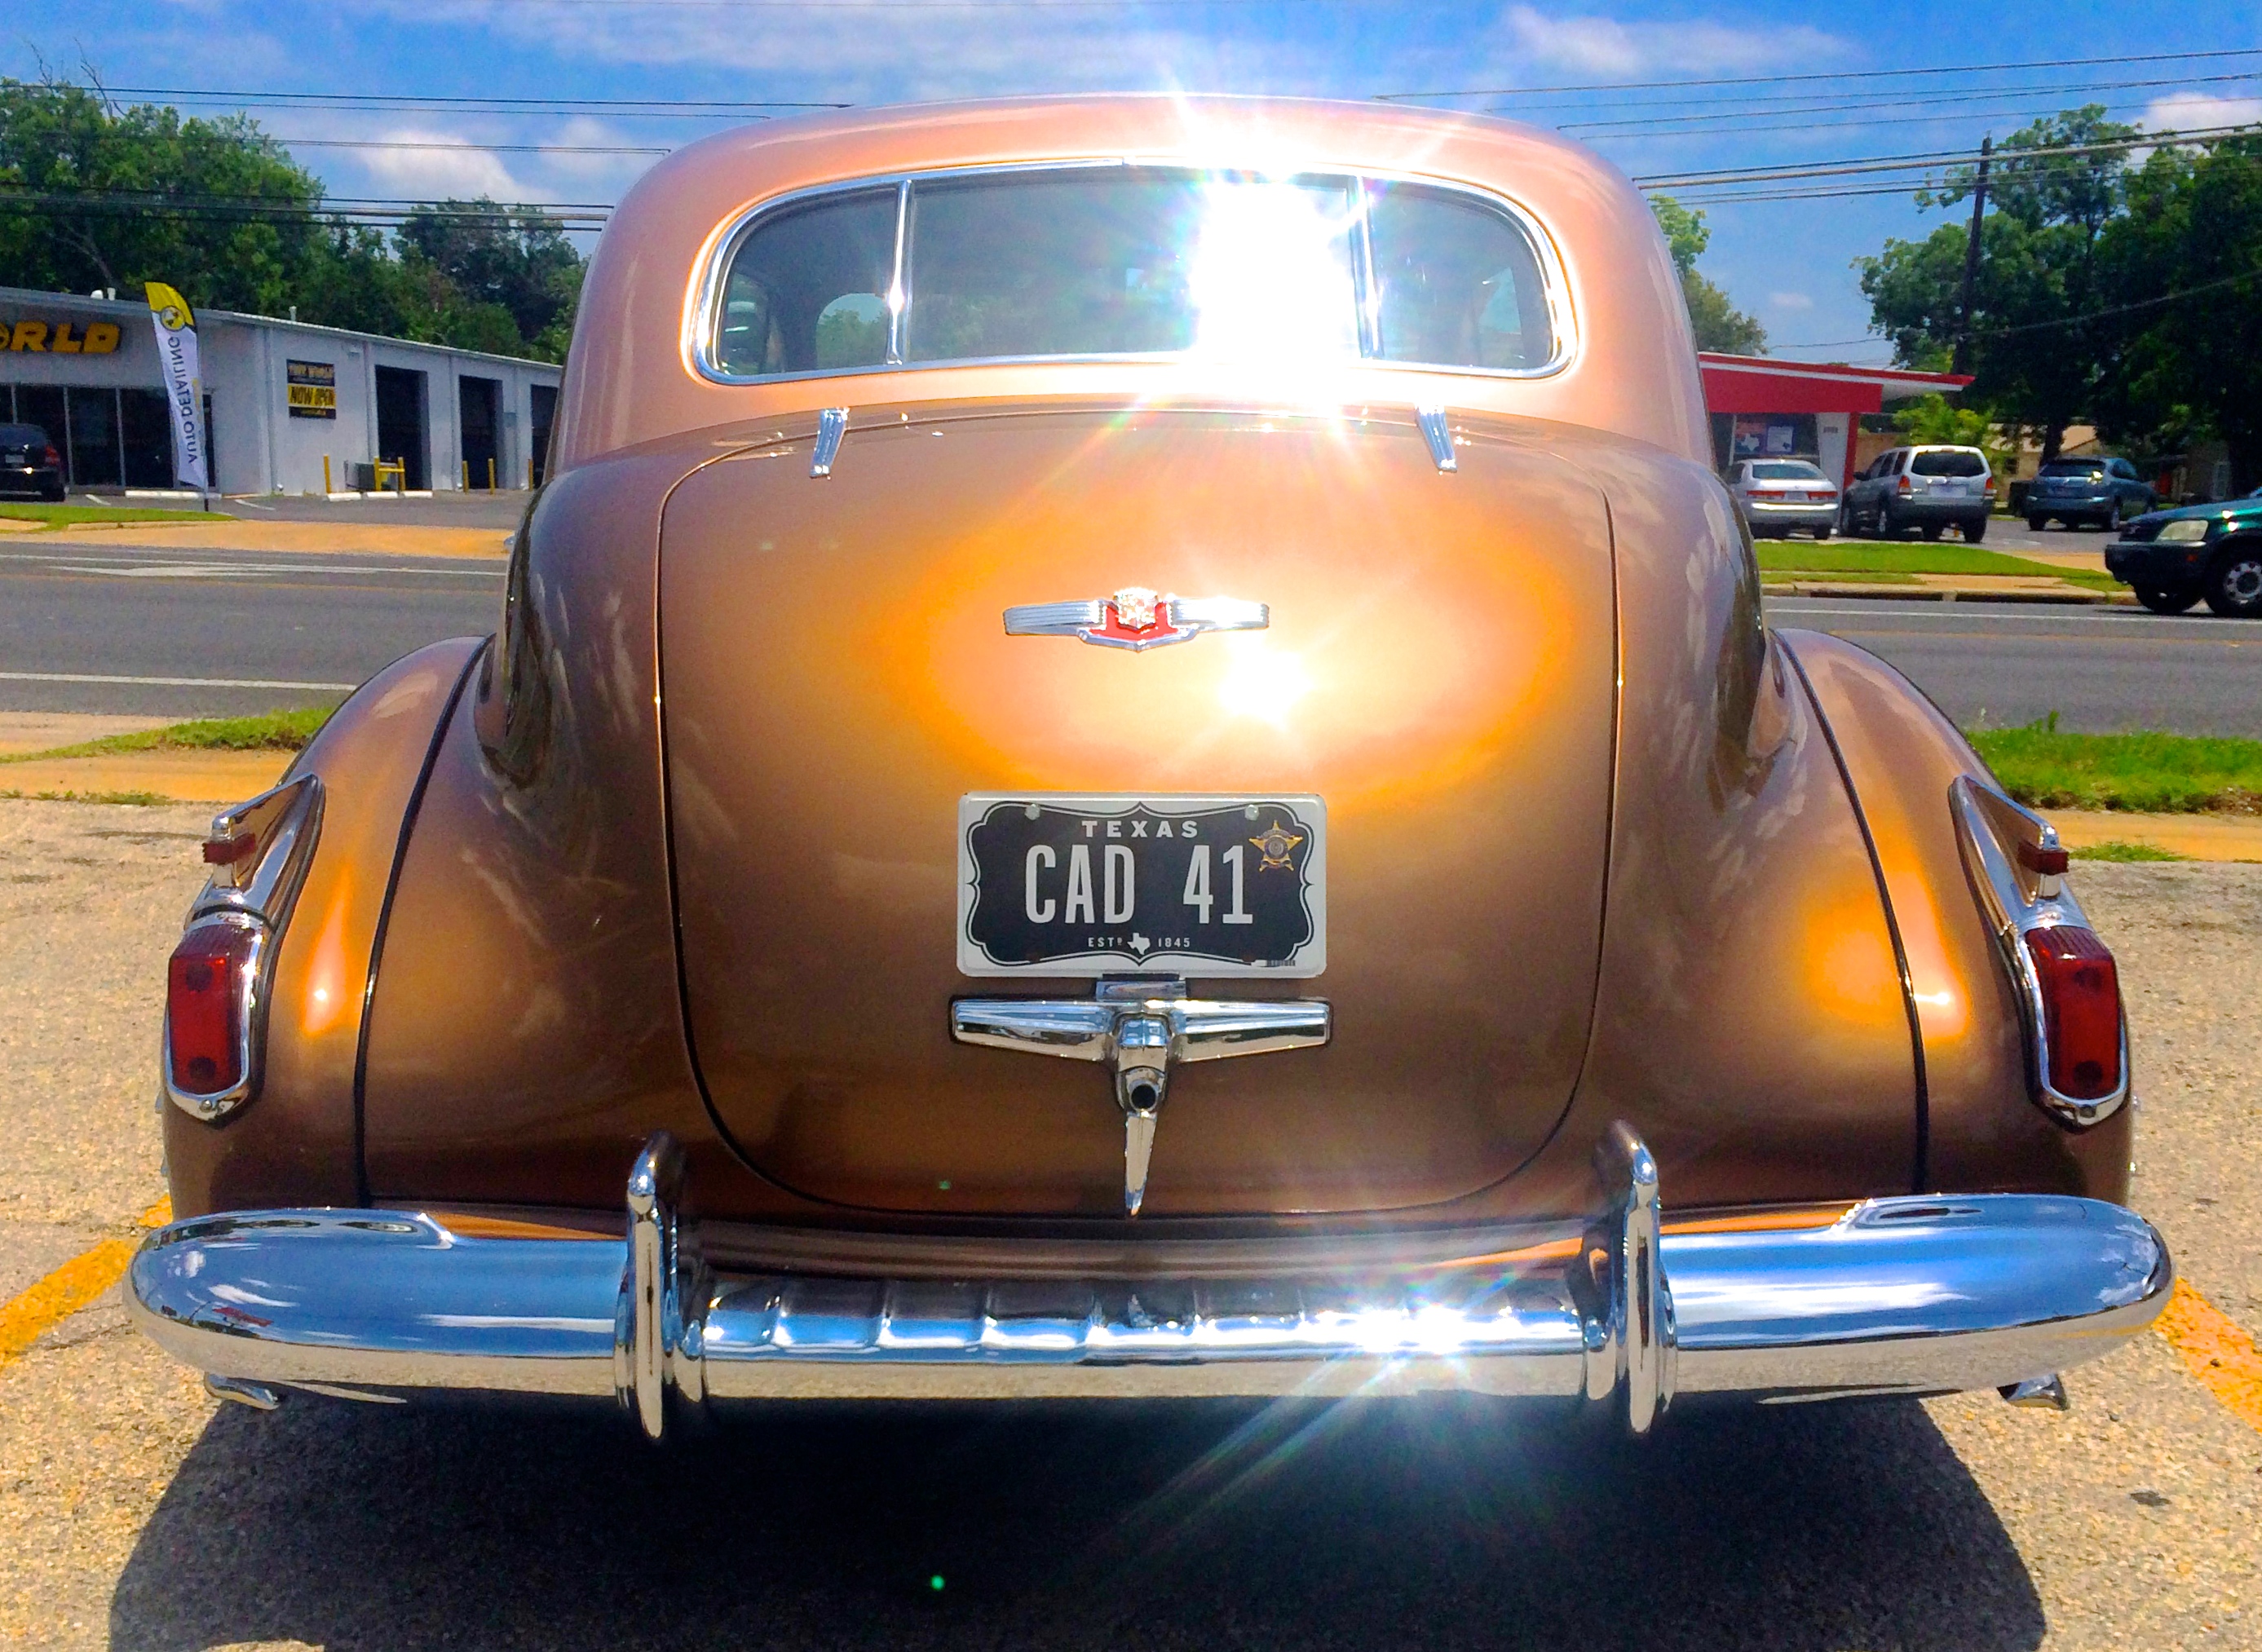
1968, 713, 2262, 815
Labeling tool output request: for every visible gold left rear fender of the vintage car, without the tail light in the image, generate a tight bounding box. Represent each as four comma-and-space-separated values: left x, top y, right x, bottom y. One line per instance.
163, 636, 484, 1217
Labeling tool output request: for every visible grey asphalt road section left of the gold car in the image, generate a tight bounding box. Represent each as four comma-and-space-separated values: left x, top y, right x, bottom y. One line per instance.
0, 539, 502, 718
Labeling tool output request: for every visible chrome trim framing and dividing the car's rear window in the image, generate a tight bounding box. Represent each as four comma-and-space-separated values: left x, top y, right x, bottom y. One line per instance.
683, 154, 1579, 387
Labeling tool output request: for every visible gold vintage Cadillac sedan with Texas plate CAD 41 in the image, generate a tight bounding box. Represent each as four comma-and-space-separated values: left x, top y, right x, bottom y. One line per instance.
131, 97, 2171, 1435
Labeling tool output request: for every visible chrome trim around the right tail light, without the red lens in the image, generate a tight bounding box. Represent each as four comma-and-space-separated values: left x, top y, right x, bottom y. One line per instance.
1947, 774, 2133, 1127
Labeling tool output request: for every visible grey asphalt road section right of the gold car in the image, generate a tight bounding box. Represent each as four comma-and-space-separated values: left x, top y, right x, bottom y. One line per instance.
1766, 597, 2262, 735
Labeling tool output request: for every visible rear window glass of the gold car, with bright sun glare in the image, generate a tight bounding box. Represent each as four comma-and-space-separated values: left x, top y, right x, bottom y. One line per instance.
710, 166, 1558, 378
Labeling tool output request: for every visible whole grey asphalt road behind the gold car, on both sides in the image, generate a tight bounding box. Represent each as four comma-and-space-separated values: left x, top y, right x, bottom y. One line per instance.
0, 533, 2262, 735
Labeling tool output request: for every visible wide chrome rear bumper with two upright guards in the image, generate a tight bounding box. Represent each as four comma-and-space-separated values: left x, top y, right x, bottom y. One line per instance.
131, 1124, 2174, 1439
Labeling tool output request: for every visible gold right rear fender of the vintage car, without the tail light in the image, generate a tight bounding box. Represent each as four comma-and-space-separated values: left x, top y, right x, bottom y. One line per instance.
1776, 631, 2133, 1204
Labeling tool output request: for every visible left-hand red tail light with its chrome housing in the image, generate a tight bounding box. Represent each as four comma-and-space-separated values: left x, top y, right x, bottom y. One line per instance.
158, 774, 321, 1123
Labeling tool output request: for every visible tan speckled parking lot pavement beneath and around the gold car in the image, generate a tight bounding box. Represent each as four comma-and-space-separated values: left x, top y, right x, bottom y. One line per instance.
0, 803, 2262, 1652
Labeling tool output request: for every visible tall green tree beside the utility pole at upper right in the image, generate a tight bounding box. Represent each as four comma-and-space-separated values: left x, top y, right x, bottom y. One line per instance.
1855, 104, 2137, 459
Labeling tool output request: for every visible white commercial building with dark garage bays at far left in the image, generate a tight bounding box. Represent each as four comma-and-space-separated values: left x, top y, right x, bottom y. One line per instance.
0, 287, 561, 493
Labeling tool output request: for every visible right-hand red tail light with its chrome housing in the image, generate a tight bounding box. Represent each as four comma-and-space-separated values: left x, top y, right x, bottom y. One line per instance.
1947, 774, 2128, 1129
